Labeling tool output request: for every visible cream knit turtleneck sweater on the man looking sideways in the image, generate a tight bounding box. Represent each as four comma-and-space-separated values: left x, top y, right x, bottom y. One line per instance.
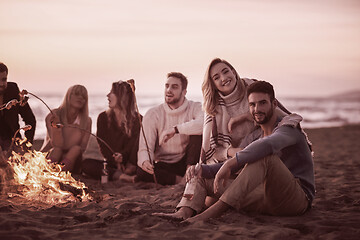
138, 99, 204, 167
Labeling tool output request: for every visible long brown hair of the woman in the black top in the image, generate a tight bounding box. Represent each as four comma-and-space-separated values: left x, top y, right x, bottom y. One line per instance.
106, 81, 138, 136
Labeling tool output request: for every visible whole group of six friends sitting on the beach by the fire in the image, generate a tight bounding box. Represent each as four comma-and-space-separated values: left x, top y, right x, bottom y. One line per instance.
0, 58, 315, 222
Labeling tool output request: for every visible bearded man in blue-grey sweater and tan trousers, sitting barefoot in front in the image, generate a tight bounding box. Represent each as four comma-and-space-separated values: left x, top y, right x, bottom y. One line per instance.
157, 81, 315, 222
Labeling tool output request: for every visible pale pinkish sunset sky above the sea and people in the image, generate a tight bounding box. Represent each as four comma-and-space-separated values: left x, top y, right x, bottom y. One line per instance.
0, 0, 360, 97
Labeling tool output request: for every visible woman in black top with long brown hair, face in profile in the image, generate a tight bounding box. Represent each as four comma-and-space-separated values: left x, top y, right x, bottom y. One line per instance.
83, 81, 140, 181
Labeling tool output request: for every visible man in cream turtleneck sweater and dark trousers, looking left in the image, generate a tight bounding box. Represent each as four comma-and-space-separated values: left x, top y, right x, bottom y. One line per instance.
137, 72, 204, 185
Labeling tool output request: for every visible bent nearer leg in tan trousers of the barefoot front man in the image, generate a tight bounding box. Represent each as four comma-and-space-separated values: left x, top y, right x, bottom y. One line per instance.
187, 156, 308, 222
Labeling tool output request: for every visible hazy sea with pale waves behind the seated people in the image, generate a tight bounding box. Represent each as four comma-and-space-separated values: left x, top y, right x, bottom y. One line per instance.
28, 94, 360, 139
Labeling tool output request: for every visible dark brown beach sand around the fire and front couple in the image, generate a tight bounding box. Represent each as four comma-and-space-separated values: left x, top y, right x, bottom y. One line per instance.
0, 125, 360, 240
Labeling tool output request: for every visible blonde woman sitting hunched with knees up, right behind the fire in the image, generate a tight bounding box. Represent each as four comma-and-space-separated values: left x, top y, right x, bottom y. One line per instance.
41, 85, 91, 173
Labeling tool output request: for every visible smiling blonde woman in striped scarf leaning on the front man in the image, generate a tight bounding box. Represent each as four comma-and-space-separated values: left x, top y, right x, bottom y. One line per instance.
201, 58, 255, 164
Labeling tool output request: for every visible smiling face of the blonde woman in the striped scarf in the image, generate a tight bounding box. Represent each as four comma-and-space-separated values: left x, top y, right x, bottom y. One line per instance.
210, 63, 236, 96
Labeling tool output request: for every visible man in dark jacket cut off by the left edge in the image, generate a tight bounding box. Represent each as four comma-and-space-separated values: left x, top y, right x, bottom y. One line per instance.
0, 62, 36, 151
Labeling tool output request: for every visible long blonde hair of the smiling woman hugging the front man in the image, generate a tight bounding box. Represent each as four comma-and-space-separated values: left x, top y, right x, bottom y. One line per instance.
202, 58, 240, 116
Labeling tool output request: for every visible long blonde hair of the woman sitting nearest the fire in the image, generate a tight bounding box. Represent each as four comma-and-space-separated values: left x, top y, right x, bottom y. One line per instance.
59, 85, 89, 129
